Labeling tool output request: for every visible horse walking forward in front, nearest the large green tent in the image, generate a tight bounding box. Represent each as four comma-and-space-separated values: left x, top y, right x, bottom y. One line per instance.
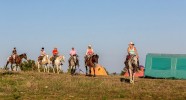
125, 55, 138, 84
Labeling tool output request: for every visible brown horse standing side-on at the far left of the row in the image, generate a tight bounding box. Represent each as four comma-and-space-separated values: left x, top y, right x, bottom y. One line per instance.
5, 53, 27, 71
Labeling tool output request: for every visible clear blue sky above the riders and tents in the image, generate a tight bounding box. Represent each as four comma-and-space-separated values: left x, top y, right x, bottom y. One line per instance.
0, 0, 186, 73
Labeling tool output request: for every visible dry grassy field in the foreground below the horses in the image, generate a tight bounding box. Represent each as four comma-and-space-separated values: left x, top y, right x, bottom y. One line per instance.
0, 72, 186, 100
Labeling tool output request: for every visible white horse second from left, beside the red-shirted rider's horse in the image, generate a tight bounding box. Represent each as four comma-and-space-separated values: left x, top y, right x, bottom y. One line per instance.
37, 55, 50, 73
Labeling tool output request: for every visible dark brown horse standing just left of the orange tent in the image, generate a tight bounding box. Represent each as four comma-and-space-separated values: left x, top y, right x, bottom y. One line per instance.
85, 54, 99, 77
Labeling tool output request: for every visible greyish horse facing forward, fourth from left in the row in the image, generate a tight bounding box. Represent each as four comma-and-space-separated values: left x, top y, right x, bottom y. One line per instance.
69, 55, 79, 75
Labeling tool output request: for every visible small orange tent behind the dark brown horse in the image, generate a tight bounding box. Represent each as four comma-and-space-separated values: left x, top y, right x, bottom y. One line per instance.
91, 64, 107, 76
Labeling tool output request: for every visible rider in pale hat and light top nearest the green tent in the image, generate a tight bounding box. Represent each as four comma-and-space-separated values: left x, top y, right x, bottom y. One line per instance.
125, 42, 139, 66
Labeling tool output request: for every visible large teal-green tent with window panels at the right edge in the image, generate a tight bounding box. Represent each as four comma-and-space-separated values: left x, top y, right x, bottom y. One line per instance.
145, 53, 186, 79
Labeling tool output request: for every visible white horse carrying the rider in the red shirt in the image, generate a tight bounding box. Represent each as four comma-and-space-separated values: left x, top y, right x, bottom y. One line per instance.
50, 55, 65, 74
